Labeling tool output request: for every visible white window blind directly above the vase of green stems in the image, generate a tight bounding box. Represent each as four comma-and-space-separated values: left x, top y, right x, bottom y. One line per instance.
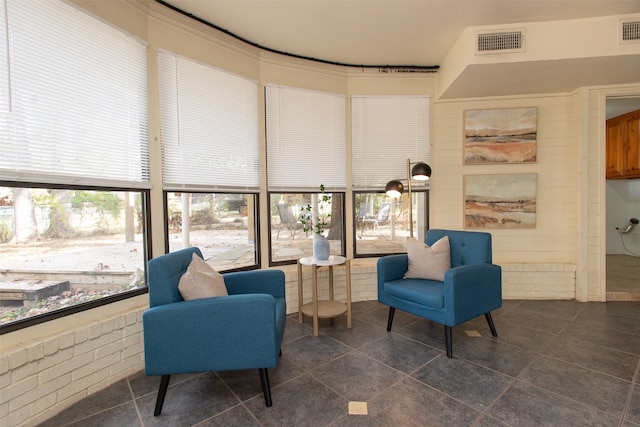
266, 86, 347, 191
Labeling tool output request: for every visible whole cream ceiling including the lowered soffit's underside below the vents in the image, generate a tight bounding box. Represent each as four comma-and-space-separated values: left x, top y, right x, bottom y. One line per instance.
161, 0, 640, 102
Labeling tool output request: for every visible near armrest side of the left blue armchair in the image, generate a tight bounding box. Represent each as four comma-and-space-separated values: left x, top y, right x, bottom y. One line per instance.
143, 294, 280, 375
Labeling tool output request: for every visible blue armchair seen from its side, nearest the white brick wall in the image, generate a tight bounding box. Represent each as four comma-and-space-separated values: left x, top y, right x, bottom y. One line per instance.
142, 248, 286, 416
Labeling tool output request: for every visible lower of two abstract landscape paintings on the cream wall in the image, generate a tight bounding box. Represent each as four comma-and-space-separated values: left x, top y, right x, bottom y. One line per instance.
464, 173, 537, 228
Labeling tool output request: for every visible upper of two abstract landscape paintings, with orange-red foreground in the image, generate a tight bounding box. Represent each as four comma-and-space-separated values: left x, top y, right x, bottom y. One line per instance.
464, 107, 538, 165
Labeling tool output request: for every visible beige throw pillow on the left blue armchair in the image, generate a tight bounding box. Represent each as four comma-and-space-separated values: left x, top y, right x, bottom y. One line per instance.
178, 253, 228, 301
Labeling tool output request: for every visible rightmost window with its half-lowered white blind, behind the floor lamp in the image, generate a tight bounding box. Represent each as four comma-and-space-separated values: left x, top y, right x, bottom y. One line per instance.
351, 96, 430, 257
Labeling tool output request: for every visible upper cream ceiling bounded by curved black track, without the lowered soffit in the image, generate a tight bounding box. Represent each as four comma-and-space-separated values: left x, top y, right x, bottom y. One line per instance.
164, 0, 640, 66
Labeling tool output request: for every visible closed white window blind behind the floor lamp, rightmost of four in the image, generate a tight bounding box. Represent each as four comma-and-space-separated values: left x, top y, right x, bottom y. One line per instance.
351, 96, 430, 190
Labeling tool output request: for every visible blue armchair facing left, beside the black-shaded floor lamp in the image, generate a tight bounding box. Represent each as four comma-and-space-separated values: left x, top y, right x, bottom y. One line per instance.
378, 229, 502, 357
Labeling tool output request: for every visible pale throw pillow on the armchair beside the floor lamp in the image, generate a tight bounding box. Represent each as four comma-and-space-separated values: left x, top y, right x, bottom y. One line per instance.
404, 236, 451, 282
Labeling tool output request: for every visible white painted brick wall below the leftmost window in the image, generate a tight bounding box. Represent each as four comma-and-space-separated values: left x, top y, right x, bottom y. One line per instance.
0, 309, 144, 427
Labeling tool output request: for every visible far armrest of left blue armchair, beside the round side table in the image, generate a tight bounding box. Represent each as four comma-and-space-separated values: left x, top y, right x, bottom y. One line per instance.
223, 270, 285, 298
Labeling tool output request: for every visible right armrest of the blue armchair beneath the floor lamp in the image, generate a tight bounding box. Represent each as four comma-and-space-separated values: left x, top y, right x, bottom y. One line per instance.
444, 264, 502, 325
